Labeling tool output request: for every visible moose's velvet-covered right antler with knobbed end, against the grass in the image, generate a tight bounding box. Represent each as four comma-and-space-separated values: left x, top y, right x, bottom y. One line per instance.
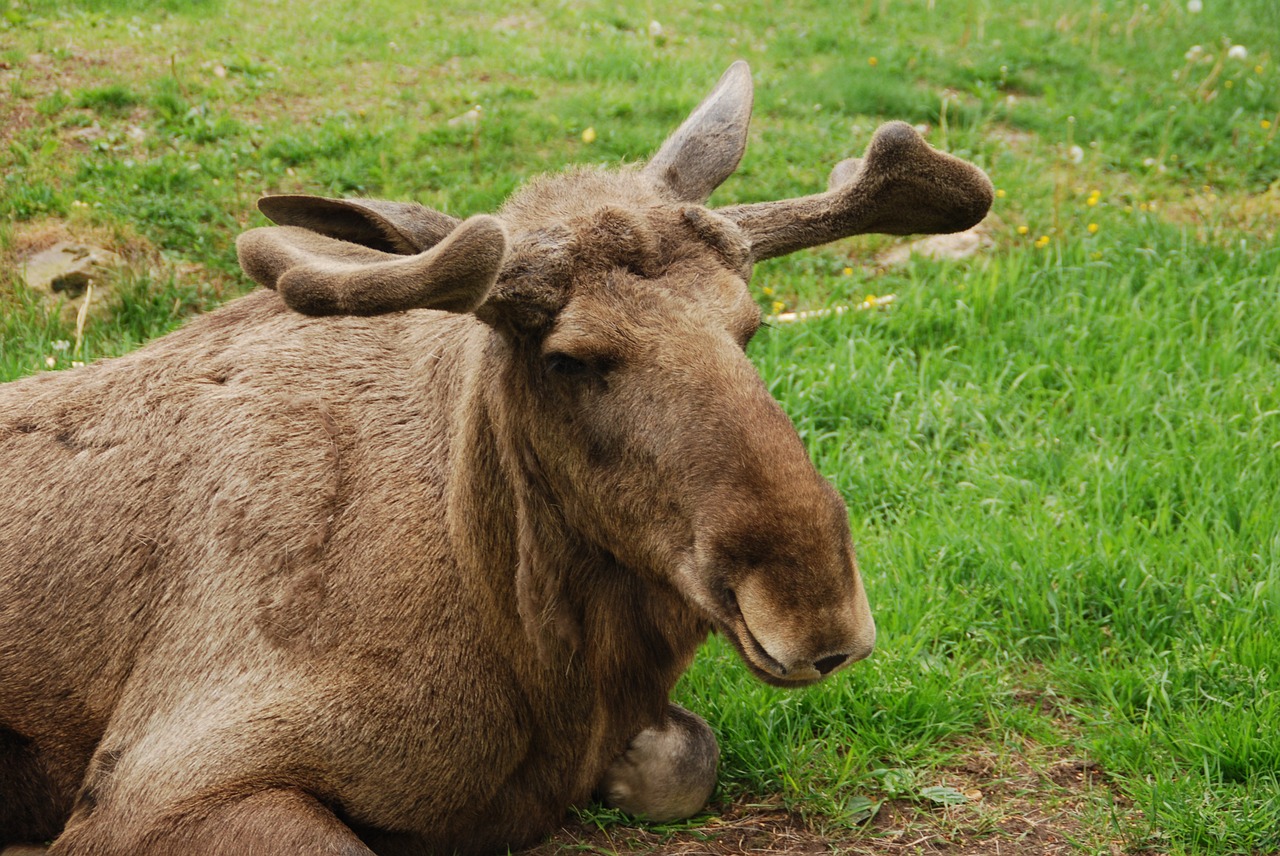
719, 122, 993, 261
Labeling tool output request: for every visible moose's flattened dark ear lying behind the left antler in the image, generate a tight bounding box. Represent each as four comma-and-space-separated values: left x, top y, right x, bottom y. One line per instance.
257, 194, 461, 256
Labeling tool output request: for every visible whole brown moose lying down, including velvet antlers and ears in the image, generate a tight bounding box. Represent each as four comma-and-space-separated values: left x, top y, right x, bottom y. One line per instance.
0, 63, 991, 856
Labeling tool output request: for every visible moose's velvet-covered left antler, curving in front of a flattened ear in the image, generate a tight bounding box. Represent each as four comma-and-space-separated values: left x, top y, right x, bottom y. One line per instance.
236, 215, 507, 315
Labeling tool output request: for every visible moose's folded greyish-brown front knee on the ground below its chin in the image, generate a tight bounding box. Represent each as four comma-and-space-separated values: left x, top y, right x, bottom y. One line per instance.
596, 704, 719, 823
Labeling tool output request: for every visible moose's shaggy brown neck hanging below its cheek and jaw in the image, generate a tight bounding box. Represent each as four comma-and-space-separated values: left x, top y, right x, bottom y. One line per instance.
449, 343, 709, 737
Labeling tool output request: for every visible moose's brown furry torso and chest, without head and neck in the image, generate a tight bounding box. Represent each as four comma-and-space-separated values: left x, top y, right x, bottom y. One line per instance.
3, 292, 707, 852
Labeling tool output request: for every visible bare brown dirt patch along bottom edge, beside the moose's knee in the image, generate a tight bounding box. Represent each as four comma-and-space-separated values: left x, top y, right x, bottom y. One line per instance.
518, 746, 1138, 856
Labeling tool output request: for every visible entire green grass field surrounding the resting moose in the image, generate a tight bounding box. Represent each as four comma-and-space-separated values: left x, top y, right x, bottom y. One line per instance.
0, 0, 1280, 855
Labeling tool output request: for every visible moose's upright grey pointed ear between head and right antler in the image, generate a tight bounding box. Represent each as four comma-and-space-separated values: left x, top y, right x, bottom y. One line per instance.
644, 60, 753, 205
